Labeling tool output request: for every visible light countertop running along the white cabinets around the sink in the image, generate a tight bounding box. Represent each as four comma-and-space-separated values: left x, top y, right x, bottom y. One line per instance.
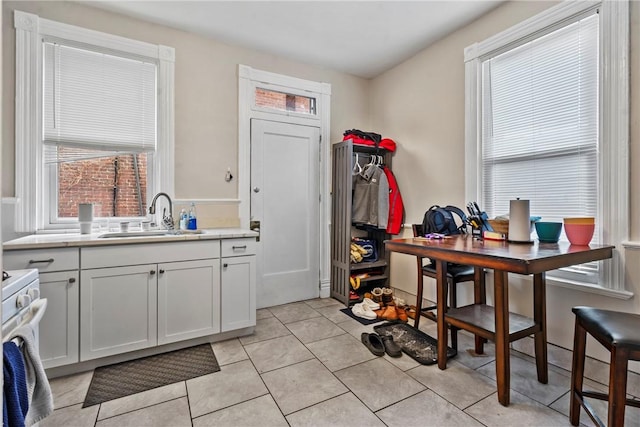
2, 228, 258, 251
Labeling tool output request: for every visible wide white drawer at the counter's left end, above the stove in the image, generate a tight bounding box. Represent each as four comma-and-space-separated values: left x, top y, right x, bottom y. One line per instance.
2, 248, 80, 273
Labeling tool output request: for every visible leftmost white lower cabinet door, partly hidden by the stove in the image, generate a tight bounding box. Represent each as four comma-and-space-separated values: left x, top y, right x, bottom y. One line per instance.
39, 270, 80, 369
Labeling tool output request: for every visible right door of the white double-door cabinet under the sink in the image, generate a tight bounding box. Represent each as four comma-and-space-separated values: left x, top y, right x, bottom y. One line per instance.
158, 258, 220, 344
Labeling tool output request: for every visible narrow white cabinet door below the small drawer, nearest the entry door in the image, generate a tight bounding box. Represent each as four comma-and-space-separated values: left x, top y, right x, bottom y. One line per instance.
221, 255, 256, 332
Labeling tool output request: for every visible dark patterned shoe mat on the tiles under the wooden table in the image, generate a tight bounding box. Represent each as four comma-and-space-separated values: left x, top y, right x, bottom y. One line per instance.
373, 322, 458, 365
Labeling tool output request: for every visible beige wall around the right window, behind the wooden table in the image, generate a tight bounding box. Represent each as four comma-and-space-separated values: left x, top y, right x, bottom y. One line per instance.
371, 1, 640, 364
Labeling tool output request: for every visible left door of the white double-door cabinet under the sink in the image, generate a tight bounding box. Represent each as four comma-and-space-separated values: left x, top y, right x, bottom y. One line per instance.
80, 264, 158, 361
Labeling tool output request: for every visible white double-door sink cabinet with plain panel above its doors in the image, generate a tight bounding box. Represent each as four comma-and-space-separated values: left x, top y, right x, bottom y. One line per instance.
80, 240, 220, 361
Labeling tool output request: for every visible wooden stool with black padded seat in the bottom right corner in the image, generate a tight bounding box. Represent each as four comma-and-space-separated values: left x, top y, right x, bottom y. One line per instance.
569, 307, 640, 427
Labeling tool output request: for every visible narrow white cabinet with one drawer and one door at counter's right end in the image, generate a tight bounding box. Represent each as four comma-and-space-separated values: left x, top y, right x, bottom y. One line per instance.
221, 238, 256, 332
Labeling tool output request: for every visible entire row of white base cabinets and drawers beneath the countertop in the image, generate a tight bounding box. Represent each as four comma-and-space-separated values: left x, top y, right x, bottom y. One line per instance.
3, 231, 256, 373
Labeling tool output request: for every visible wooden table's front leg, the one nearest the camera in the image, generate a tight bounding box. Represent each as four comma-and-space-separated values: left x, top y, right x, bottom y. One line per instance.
493, 270, 511, 406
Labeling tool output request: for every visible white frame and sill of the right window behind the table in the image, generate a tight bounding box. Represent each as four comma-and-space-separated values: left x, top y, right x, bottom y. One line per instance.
464, 0, 632, 298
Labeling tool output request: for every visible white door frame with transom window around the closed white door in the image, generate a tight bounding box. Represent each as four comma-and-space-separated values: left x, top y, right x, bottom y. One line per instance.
238, 64, 331, 298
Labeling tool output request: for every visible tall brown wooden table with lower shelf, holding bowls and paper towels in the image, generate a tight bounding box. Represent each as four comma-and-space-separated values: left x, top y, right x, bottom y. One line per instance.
385, 235, 614, 406
